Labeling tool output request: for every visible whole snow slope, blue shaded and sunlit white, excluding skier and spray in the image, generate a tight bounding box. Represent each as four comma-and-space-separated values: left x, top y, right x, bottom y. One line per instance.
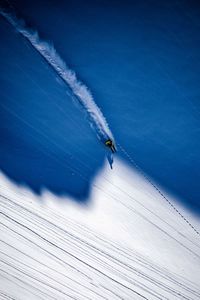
0, 0, 200, 300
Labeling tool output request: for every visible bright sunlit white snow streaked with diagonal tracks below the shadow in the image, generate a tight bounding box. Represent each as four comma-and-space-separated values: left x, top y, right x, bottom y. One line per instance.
0, 160, 200, 300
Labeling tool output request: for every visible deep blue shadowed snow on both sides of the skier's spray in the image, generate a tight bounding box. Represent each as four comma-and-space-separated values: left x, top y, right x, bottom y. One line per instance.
0, 0, 200, 211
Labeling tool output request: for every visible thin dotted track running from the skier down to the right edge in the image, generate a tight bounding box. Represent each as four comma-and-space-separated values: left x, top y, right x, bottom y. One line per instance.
117, 143, 200, 237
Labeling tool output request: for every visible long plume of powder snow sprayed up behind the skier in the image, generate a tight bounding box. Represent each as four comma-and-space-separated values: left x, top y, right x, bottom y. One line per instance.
0, 7, 114, 142
